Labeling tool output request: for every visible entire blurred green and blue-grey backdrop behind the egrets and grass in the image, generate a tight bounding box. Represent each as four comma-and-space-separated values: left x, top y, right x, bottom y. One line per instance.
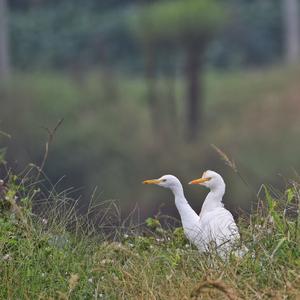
0, 0, 300, 218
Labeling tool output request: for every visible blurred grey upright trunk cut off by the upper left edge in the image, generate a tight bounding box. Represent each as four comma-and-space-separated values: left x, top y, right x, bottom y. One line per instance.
0, 0, 10, 79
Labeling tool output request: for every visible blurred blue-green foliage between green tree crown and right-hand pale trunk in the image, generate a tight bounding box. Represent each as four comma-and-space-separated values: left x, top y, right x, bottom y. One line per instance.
206, 0, 284, 69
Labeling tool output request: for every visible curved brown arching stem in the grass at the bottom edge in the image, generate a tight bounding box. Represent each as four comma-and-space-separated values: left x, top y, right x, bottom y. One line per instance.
191, 279, 240, 300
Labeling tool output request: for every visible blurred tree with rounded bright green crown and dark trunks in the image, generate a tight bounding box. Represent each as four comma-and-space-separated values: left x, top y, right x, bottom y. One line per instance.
130, 0, 225, 141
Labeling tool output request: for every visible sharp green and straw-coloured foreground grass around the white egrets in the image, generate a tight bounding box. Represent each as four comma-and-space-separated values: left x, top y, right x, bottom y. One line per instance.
0, 171, 300, 299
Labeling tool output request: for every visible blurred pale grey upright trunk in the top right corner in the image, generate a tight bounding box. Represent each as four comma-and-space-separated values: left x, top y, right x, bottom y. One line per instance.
282, 0, 300, 63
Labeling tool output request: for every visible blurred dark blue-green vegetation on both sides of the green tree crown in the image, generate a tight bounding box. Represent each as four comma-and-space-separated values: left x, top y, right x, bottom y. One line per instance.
9, 0, 284, 72
